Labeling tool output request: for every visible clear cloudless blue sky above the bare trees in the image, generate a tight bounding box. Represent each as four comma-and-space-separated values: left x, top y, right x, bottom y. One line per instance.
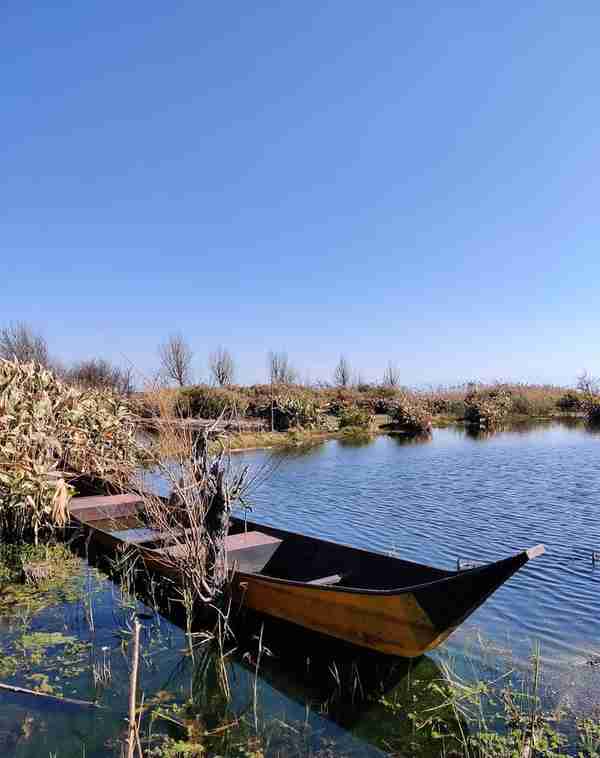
0, 0, 600, 385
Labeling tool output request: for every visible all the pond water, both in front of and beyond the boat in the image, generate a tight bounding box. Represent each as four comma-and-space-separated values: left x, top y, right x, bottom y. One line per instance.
0, 424, 600, 758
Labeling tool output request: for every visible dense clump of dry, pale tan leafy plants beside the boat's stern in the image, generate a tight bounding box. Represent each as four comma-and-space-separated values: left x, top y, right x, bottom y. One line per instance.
0, 360, 143, 543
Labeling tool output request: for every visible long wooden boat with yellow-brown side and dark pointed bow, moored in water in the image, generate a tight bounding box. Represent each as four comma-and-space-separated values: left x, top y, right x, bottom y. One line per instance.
71, 495, 544, 657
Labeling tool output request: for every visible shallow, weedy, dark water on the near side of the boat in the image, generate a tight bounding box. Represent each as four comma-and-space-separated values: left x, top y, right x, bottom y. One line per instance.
0, 560, 440, 758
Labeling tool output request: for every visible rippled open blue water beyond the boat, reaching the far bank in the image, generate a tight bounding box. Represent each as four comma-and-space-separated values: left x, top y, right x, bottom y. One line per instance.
232, 423, 600, 663
